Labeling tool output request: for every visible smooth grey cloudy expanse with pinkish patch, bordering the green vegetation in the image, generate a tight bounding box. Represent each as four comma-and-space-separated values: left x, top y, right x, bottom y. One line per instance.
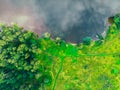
0, 0, 120, 43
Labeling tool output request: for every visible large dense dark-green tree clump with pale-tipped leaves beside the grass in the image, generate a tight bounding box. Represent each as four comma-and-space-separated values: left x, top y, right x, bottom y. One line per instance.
0, 24, 51, 90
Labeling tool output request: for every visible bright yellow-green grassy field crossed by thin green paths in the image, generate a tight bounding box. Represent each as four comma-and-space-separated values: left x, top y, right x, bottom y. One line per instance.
40, 16, 120, 90
